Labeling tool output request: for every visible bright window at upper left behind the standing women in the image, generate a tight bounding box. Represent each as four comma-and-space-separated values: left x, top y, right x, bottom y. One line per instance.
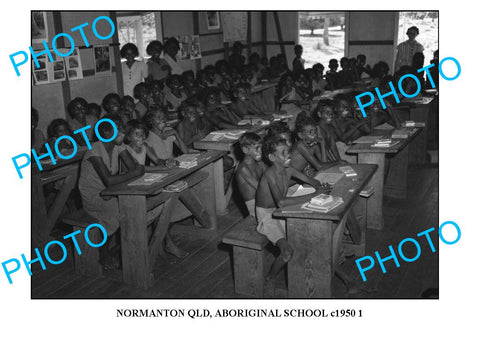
117, 12, 157, 58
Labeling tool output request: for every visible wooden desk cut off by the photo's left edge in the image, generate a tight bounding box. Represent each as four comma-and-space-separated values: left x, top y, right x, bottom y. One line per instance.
31, 148, 87, 246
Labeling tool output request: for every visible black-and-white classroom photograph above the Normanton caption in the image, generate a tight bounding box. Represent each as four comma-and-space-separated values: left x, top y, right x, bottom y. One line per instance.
32, 11, 439, 299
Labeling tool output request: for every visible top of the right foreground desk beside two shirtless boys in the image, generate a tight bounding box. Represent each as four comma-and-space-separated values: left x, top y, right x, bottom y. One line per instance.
273, 164, 378, 221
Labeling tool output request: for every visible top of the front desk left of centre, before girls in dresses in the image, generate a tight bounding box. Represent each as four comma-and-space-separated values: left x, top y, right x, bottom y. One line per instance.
101, 151, 225, 196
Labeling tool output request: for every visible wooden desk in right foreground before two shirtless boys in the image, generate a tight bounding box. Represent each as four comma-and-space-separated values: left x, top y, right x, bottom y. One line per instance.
273, 164, 377, 298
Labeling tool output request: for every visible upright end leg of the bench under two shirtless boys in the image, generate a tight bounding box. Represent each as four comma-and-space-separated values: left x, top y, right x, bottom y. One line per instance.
233, 246, 266, 298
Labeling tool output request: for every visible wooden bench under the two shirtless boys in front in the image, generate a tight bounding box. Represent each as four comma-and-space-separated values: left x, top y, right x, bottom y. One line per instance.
223, 216, 269, 298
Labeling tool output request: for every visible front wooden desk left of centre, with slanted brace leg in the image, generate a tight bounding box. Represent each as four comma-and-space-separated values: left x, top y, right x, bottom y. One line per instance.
101, 151, 225, 289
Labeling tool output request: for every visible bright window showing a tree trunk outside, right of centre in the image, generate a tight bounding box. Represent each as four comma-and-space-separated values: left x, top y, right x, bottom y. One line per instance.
298, 12, 345, 69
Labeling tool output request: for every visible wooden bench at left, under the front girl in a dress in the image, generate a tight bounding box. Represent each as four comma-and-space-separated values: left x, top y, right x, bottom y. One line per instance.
62, 209, 103, 277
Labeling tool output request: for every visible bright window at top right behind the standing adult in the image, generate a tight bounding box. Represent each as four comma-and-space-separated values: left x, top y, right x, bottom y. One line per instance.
398, 12, 438, 61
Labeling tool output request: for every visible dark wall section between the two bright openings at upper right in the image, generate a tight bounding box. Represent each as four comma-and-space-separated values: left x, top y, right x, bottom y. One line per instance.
345, 12, 398, 70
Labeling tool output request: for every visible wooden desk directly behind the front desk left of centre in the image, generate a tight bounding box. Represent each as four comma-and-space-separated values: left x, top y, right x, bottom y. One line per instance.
193, 125, 268, 215
